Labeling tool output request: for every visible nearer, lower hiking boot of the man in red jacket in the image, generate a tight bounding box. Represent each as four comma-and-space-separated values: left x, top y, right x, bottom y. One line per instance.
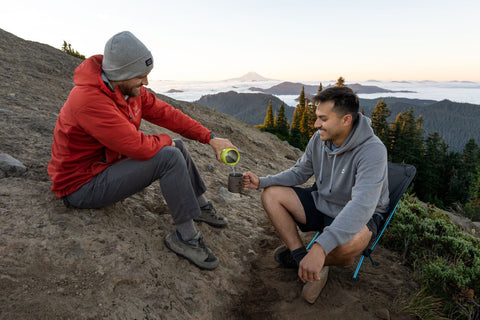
165, 231, 219, 270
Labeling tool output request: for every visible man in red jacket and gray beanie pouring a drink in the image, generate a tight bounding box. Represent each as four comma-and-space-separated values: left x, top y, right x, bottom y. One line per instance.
48, 31, 235, 270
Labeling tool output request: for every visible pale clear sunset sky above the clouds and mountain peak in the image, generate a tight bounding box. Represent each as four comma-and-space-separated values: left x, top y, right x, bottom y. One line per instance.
0, 0, 480, 82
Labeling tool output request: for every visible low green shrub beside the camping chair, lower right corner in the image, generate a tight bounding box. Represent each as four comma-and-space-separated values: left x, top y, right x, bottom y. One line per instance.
382, 195, 480, 319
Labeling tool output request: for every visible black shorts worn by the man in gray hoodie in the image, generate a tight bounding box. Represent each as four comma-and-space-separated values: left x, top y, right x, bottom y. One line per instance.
292, 186, 383, 240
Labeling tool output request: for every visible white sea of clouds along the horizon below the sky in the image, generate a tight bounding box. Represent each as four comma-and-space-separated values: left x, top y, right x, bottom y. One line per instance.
148, 80, 480, 107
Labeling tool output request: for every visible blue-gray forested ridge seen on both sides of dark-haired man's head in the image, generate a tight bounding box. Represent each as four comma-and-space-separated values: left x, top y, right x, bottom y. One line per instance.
196, 91, 480, 152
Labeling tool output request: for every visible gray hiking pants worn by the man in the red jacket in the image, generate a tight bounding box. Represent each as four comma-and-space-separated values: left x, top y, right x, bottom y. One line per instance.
64, 139, 207, 224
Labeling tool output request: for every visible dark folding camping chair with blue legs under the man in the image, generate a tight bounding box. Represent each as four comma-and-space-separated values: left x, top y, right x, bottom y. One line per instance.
307, 162, 417, 280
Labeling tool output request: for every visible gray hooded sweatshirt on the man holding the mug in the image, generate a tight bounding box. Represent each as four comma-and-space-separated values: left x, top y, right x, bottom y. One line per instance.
260, 114, 389, 254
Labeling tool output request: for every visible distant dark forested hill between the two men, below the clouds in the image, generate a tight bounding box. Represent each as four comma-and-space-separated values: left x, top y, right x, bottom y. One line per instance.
195, 91, 294, 125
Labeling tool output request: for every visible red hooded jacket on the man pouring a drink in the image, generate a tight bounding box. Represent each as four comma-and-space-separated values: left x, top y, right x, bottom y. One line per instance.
48, 55, 211, 197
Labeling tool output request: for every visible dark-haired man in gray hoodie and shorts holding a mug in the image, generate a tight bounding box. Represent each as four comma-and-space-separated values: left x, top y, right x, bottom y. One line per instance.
243, 87, 389, 303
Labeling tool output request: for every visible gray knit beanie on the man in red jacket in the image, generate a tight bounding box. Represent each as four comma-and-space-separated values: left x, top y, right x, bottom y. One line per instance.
102, 31, 153, 81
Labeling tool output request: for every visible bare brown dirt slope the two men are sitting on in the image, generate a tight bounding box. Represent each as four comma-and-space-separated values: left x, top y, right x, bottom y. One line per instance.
0, 29, 416, 320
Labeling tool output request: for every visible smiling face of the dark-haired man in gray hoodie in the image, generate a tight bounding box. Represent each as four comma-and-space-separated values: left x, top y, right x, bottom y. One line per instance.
314, 101, 351, 147
